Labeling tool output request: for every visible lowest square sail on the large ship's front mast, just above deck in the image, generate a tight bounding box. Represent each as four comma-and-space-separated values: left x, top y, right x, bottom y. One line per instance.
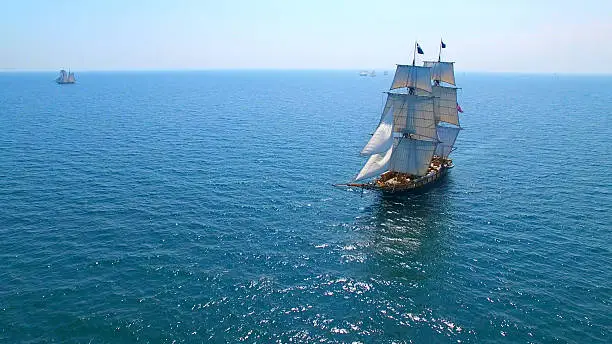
389, 138, 436, 176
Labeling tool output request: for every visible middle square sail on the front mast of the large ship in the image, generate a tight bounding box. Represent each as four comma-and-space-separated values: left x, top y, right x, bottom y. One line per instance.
381, 93, 436, 139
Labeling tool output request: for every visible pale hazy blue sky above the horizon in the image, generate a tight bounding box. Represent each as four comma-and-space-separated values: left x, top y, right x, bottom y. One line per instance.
0, 0, 612, 73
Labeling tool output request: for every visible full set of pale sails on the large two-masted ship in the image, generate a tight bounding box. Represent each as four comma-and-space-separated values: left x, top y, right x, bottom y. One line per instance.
354, 51, 461, 181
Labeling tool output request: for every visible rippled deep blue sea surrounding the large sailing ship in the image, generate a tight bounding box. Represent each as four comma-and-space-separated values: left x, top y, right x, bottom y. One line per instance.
0, 71, 612, 343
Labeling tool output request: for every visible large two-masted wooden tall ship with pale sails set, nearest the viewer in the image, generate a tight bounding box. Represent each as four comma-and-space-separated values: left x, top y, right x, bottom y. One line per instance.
337, 40, 463, 193
